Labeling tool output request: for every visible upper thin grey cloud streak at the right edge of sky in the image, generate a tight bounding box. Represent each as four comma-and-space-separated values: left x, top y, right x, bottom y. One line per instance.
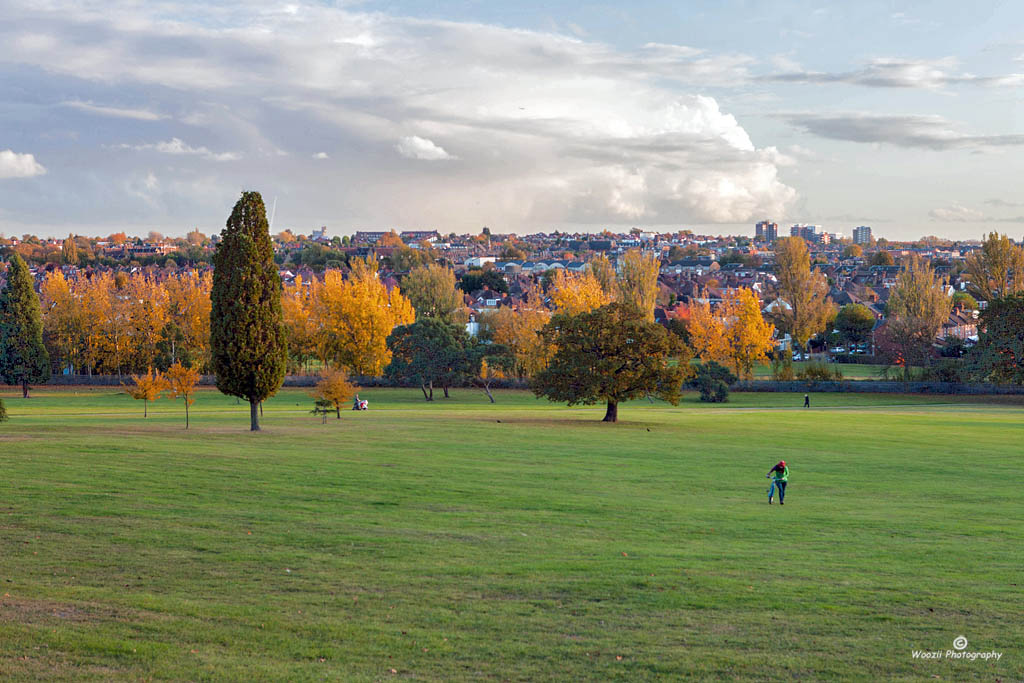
762, 57, 1024, 90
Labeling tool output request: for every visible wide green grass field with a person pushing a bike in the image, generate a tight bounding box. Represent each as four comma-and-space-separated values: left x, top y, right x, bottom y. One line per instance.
0, 389, 1024, 681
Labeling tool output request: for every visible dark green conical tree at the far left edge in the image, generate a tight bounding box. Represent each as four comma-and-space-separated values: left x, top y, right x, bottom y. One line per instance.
0, 253, 50, 398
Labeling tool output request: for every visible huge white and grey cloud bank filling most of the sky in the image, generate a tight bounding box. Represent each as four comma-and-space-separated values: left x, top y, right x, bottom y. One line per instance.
0, 0, 797, 229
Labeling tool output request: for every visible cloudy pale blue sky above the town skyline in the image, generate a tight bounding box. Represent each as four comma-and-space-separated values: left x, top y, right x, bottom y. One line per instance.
0, 0, 1024, 240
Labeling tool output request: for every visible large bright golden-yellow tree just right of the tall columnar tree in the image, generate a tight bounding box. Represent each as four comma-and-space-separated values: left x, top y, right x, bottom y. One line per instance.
313, 258, 416, 377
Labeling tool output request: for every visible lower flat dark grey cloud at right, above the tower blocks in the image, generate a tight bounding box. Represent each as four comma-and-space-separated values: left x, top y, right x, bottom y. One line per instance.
780, 113, 1024, 151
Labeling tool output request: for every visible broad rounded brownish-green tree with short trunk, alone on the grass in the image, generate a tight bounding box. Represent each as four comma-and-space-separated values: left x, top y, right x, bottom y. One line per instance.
531, 303, 690, 422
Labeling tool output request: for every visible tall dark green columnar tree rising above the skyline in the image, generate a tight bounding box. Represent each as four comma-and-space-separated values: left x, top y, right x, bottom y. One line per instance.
210, 193, 288, 431
